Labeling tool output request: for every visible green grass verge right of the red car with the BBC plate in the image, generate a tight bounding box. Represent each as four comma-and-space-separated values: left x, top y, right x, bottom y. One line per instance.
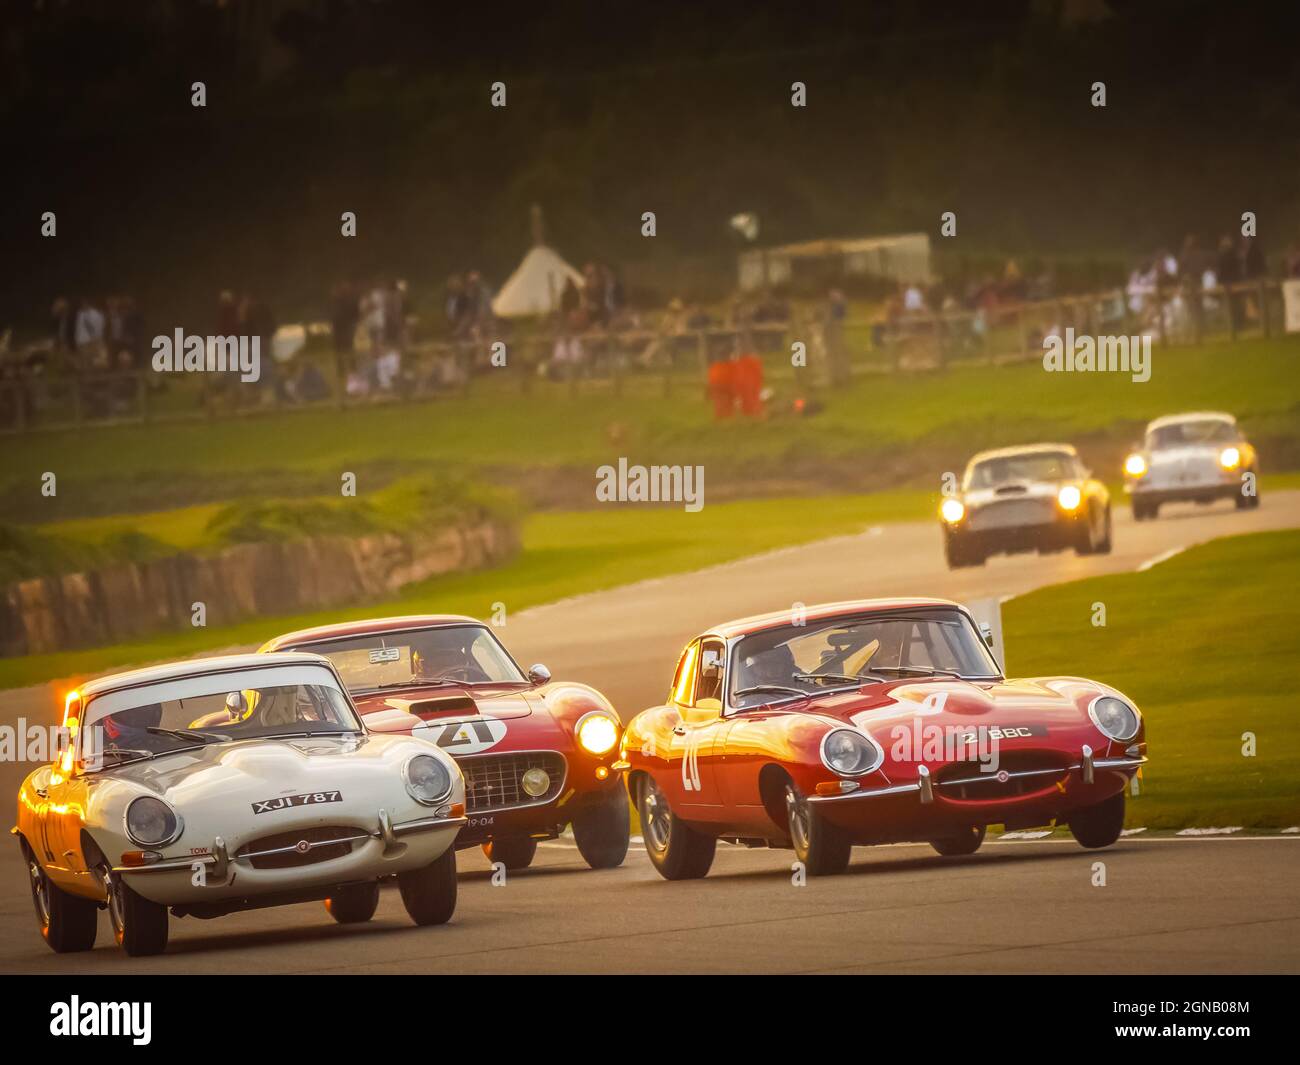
1002, 531, 1300, 830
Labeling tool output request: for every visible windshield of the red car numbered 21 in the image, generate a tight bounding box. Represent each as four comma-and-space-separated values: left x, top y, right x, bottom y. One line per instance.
299, 625, 527, 692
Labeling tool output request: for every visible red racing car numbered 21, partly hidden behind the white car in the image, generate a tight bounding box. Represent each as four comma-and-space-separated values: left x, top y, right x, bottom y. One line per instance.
261, 615, 629, 869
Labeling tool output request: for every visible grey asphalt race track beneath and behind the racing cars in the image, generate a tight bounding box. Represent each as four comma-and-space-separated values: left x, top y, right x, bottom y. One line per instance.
0, 492, 1300, 973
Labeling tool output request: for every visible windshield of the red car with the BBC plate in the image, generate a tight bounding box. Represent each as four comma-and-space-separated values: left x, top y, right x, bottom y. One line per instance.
728, 610, 1000, 707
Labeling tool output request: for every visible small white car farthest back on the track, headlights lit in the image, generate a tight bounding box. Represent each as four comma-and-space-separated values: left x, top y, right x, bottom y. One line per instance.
1125, 411, 1260, 521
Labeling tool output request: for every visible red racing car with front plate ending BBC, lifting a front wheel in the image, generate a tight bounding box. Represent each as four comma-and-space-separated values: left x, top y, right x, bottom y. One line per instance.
619, 599, 1147, 880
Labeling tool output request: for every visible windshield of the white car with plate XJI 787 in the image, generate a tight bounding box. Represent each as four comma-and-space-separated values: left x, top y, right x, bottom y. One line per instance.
79, 666, 361, 772
